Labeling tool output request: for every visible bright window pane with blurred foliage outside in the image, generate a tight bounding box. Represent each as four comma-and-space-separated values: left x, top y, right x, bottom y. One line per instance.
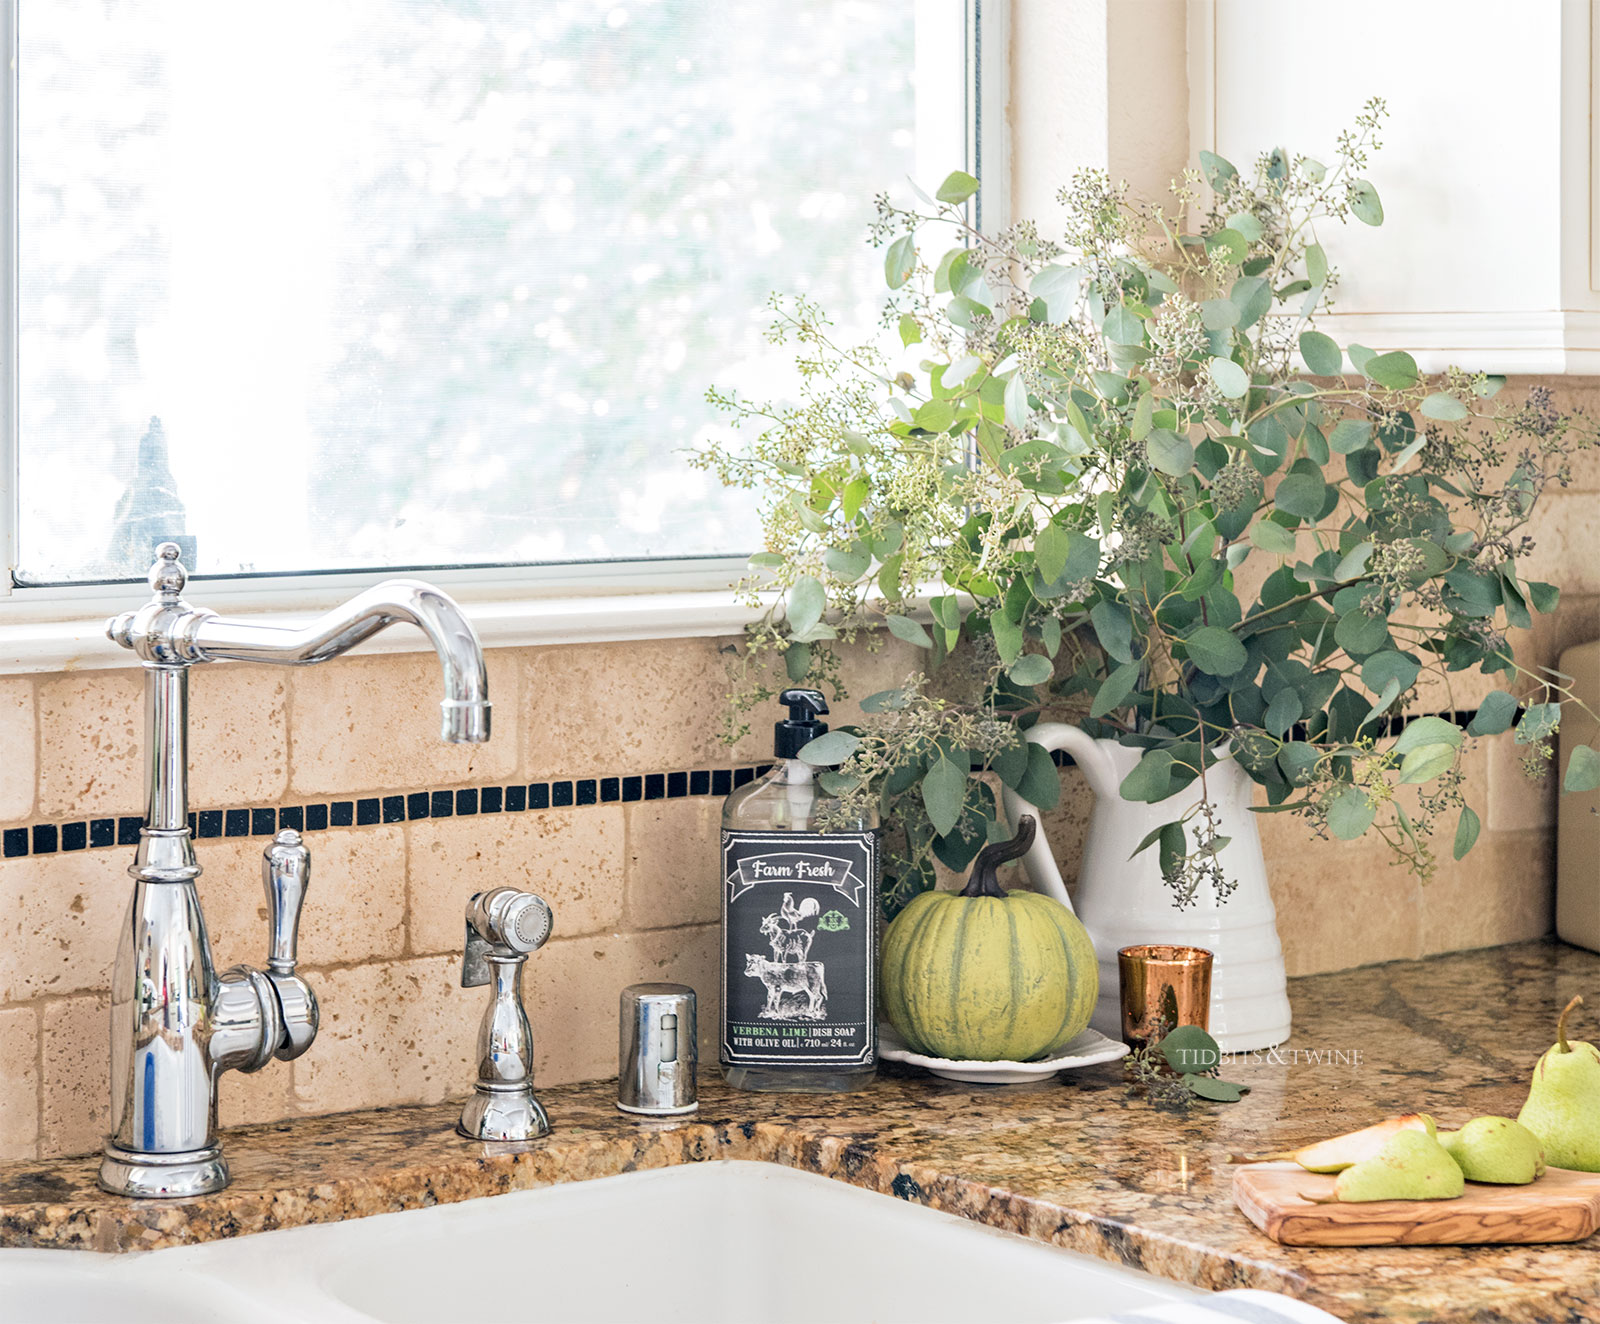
9, 0, 970, 585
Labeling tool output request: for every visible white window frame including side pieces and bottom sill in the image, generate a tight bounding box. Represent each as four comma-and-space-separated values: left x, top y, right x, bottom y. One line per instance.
0, 0, 1010, 675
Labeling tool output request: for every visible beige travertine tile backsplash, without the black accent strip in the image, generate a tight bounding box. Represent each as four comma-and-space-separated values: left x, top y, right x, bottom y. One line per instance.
0, 374, 1600, 1158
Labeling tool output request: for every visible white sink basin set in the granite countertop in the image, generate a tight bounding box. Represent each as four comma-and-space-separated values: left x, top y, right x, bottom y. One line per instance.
0, 1162, 1198, 1324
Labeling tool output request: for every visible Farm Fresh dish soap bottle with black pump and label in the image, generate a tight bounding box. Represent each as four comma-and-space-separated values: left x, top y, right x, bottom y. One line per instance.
722, 689, 878, 1092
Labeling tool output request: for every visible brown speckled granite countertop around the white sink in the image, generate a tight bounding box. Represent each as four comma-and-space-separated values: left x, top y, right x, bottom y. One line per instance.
0, 942, 1600, 1324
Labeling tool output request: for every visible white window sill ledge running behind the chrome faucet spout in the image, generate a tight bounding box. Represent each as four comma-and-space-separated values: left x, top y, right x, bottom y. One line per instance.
0, 560, 758, 675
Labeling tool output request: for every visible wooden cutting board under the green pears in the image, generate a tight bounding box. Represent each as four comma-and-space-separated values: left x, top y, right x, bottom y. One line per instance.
1234, 1162, 1600, 1246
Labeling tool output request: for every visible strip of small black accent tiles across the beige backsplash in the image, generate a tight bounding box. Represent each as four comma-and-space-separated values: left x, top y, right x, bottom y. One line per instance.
0, 710, 1477, 860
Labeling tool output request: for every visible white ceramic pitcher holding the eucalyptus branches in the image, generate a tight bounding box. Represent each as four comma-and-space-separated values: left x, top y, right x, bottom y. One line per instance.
1005, 723, 1290, 1052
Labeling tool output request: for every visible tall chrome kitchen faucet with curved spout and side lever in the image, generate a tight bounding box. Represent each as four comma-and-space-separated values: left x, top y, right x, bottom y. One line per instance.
99, 542, 490, 1198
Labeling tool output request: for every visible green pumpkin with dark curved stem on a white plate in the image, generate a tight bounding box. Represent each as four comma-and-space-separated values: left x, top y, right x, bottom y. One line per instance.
882, 817, 1099, 1062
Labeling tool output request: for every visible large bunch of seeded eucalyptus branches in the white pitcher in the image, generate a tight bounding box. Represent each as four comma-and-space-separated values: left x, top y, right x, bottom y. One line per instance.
696, 101, 1600, 913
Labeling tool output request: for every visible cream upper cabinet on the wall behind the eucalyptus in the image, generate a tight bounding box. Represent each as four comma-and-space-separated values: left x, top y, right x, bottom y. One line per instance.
1187, 0, 1600, 374
